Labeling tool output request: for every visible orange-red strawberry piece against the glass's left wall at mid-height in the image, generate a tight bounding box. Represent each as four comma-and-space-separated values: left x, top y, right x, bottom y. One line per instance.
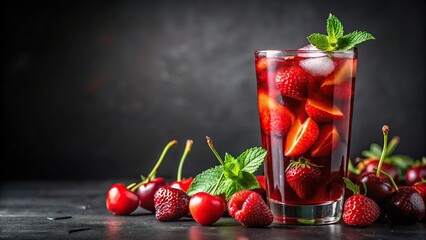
258, 91, 293, 137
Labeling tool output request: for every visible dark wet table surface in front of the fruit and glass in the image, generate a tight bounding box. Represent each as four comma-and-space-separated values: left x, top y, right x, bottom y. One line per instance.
0, 181, 426, 240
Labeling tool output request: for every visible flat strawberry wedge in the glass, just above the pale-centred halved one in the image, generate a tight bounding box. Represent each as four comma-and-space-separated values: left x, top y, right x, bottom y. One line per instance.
305, 98, 344, 122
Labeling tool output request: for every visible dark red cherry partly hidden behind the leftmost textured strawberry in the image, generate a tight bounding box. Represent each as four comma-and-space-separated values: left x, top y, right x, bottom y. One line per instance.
136, 177, 167, 212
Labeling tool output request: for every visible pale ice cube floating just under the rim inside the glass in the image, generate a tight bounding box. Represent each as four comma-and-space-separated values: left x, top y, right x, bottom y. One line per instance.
299, 57, 334, 76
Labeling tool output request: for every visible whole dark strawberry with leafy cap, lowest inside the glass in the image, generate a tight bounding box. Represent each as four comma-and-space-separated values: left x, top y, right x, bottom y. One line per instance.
285, 157, 321, 199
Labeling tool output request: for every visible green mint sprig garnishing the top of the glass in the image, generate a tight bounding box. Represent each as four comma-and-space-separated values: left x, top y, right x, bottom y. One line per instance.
307, 13, 375, 51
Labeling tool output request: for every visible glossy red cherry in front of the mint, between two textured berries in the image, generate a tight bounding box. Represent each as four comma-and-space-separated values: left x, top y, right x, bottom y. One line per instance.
189, 192, 225, 226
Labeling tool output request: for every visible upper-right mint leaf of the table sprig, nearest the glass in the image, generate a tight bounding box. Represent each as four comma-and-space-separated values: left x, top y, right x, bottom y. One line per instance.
237, 147, 267, 173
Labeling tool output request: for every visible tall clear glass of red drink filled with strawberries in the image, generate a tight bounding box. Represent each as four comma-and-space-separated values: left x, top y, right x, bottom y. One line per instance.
255, 50, 357, 224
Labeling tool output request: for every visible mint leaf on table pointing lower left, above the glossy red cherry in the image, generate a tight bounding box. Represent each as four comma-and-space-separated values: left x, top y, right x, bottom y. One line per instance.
186, 165, 223, 196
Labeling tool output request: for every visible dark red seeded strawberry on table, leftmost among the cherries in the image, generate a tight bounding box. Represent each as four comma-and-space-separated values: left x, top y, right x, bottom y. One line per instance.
154, 186, 190, 222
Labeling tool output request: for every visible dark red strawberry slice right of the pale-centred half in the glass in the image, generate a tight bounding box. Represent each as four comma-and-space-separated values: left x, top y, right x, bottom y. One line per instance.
311, 124, 340, 157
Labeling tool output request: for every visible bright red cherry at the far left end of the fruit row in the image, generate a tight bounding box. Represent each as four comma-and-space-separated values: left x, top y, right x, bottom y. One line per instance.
106, 183, 139, 215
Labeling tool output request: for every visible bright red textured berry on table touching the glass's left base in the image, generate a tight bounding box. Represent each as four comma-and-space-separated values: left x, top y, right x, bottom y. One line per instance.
228, 190, 274, 227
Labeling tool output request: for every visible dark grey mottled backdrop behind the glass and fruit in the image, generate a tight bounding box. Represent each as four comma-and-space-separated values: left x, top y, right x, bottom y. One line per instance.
1, 0, 426, 179
